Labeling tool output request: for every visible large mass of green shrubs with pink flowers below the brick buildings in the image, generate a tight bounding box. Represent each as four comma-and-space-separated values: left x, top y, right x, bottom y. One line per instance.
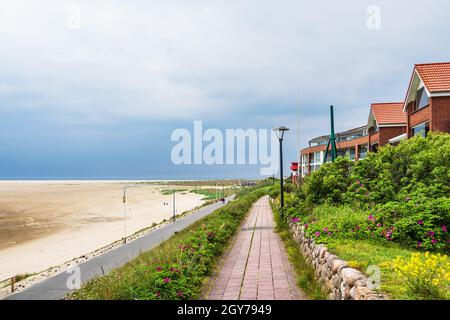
285, 134, 450, 252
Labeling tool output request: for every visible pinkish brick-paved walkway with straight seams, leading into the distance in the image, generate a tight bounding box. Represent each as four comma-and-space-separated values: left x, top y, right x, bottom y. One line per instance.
207, 196, 306, 300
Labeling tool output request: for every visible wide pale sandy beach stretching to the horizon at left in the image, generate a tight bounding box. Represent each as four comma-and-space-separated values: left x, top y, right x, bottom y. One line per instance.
0, 181, 204, 281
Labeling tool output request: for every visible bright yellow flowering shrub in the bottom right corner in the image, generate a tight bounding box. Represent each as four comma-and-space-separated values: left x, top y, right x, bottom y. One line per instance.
392, 252, 450, 299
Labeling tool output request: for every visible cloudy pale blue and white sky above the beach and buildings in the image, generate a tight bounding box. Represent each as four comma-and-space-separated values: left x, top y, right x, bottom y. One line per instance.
0, 0, 450, 179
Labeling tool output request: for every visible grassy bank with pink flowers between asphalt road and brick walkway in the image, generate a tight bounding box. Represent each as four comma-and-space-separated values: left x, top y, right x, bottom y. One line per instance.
69, 188, 267, 300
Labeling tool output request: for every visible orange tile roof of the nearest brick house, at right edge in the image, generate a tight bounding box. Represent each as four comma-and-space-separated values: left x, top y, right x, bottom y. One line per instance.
415, 62, 450, 92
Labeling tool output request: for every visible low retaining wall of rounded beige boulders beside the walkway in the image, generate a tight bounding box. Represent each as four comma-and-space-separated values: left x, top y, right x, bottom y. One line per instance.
289, 222, 387, 300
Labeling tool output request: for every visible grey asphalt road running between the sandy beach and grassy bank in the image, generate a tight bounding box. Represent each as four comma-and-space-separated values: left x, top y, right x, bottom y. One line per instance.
5, 197, 233, 300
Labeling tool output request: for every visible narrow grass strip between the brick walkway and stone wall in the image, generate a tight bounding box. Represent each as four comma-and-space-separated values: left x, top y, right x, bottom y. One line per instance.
272, 202, 326, 300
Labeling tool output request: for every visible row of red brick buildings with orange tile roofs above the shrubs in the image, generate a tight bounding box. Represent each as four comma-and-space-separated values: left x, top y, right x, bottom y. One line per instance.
295, 62, 450, 176
